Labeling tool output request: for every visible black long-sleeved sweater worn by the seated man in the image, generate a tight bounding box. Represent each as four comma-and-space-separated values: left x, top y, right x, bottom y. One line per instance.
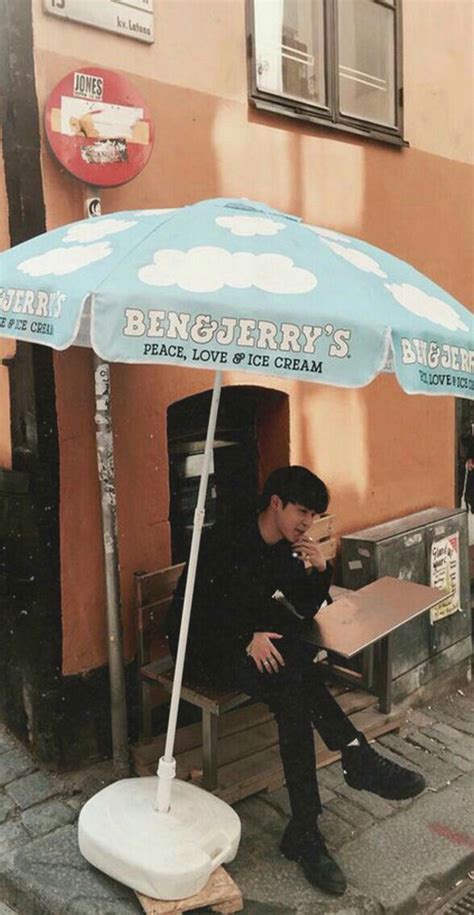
167, 517, 332, 676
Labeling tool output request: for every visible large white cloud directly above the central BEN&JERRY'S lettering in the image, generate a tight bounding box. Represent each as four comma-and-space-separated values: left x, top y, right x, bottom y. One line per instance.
138, 246, 317, 295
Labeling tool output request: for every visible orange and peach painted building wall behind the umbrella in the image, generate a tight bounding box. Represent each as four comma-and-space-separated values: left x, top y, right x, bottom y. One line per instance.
28, 0, 472, 673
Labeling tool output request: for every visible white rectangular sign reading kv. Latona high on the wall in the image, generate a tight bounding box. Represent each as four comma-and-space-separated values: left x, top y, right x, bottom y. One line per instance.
43, 0, 155, 44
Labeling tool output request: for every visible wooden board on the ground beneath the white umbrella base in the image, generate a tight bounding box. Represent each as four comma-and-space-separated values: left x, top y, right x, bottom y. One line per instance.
136, 867, 244, 915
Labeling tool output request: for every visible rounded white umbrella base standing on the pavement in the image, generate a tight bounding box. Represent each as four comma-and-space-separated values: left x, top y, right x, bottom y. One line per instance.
79, 777, 240, 899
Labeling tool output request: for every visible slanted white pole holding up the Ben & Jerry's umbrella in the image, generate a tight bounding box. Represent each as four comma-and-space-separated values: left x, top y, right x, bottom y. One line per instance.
156, 372, 222, 813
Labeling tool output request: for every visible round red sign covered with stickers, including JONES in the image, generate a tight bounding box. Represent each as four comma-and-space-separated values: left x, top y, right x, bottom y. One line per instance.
45, 67, 153, 187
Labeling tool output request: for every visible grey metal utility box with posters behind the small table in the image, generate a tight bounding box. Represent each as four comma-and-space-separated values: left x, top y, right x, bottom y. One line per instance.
341, 508, 471, 698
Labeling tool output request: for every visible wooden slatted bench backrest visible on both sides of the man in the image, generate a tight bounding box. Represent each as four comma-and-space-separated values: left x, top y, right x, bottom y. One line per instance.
135, 515, 336, 667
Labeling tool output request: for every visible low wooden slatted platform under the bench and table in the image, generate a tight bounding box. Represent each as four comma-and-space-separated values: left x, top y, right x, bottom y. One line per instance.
132, 686, 404, 804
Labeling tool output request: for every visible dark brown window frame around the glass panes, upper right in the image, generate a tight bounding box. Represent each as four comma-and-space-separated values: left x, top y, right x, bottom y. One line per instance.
246, 0, 409, 146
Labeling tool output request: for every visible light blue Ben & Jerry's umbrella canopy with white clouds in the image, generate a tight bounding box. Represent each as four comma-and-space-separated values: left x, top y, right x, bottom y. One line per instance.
0, 199, 474, 398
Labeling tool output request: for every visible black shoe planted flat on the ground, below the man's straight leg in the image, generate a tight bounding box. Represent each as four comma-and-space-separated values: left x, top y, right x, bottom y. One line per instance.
280, 820, 347, 896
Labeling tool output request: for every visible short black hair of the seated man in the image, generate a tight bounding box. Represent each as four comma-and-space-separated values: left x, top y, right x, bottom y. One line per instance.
260, 466, 329, 515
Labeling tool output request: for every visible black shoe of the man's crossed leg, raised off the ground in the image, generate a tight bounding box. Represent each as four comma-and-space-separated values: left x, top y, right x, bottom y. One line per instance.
341, 734, 426, 801
